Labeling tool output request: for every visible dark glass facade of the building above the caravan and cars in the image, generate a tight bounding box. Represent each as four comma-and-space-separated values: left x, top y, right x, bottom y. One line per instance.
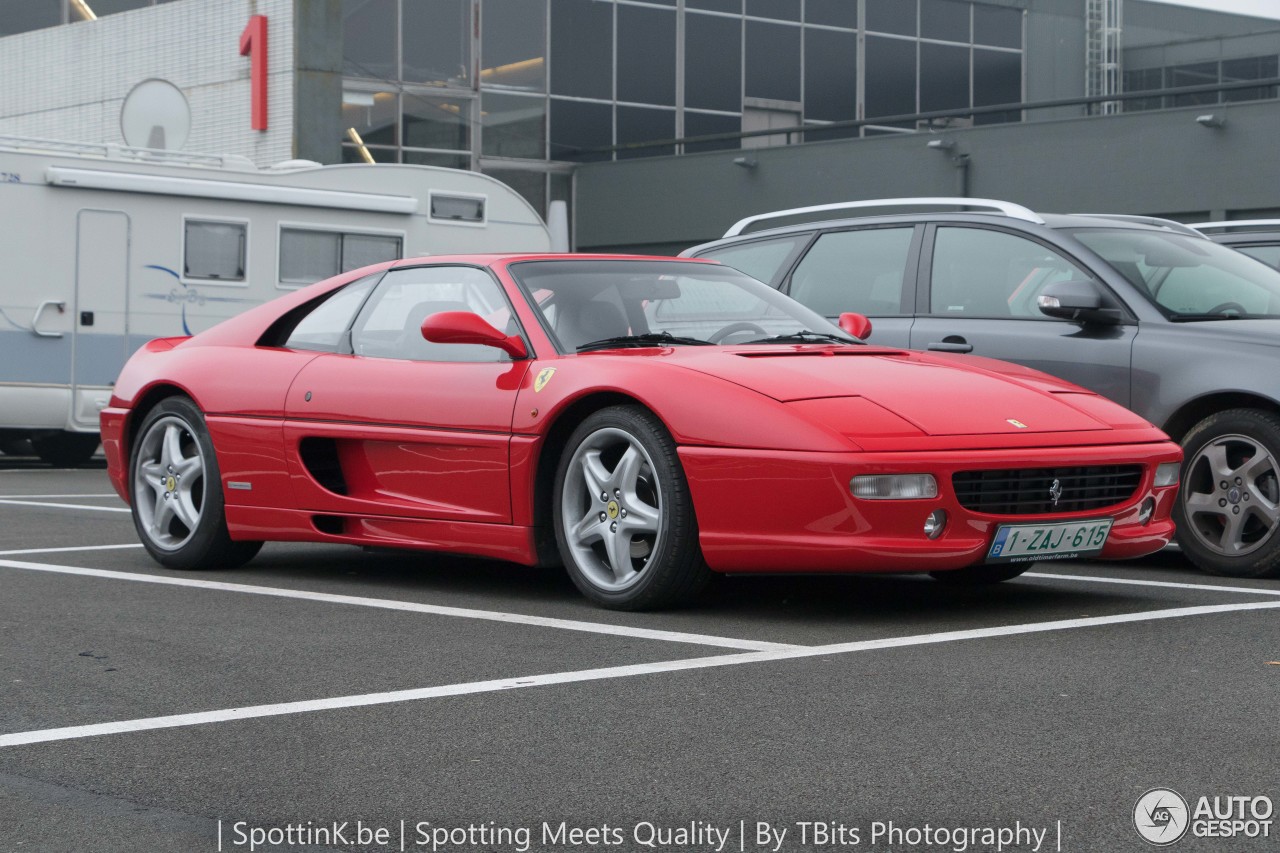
343, 0, 1025, 211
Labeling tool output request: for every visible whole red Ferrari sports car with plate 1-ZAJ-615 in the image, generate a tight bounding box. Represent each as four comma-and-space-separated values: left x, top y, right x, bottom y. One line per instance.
101, 255, 1180, 610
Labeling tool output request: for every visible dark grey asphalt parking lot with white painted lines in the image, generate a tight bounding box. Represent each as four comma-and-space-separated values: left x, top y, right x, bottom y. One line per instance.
0, 457, 1280, 853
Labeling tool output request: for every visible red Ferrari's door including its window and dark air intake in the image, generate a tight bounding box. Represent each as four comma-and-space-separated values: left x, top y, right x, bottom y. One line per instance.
284, 265, 529, 524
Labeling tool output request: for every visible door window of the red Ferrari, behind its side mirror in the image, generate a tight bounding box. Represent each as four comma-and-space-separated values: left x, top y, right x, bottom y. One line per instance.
351, 266, 513, 361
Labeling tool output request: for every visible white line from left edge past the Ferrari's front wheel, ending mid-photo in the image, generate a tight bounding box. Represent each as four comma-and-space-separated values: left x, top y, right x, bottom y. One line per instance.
0, 560, 804, 651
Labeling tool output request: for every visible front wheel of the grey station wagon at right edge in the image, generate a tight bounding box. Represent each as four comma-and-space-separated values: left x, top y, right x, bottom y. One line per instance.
1174, 409, 1280, 578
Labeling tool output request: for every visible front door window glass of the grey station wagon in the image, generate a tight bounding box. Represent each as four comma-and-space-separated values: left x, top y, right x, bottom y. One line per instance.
929, 227, 1092, 321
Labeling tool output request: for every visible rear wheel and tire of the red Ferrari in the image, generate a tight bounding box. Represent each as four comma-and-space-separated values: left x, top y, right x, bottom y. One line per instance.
129, 397, 262, 570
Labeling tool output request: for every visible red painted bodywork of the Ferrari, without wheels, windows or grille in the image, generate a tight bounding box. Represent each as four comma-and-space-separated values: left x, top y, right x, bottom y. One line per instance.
101, 256, 1180, 571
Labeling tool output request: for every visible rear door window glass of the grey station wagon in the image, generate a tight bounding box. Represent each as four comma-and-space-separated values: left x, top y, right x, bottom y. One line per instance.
791, 228, 914, 316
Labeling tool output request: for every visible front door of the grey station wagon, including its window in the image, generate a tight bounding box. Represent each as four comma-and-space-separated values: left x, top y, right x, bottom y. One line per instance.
910, 224, 1138, 406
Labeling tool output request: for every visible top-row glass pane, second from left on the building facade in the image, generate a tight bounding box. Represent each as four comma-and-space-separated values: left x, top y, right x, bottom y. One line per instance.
401, 0, 471, 86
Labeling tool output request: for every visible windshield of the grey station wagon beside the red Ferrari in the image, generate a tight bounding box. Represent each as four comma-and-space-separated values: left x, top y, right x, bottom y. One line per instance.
1075, 228, 1280, 320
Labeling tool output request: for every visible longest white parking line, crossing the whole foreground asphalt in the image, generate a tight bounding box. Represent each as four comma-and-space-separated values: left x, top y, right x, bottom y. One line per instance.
0, 601, 1280, 747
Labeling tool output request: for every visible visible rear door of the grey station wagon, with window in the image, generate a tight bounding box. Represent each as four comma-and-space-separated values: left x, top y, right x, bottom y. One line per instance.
783, 224, 923, 347
